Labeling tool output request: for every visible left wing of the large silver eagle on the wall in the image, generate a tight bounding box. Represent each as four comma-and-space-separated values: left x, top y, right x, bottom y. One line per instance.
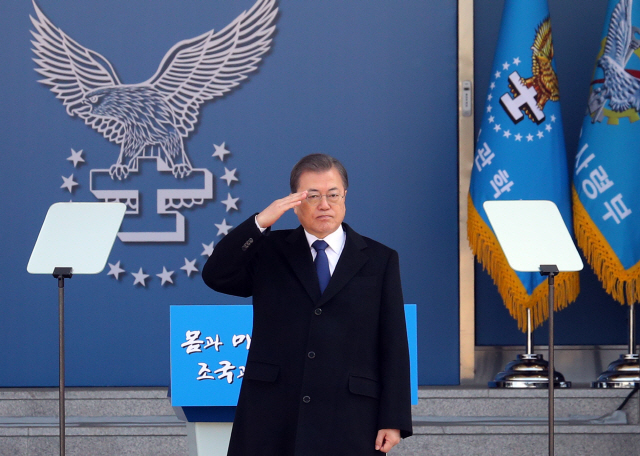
30, 1, 124, 144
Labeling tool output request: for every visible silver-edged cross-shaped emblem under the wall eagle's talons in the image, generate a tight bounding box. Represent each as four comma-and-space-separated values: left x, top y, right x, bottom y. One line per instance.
89, 157, 213, 242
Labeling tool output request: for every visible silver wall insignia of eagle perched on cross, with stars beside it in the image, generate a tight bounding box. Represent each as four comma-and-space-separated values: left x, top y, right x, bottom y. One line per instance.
31, 0, 278, 249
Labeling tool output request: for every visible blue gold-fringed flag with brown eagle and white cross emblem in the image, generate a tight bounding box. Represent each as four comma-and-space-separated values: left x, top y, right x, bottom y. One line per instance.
467, 0, 579, 330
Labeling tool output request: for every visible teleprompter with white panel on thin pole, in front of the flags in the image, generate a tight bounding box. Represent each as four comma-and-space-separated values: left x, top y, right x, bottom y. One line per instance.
483, 200, 583, 456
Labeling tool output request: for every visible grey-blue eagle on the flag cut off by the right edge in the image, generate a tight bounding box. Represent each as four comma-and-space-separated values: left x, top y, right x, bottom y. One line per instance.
589, 0, 640, 123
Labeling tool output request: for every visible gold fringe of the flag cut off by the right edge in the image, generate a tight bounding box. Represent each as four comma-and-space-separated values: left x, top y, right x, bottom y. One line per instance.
572, 187, 640, 305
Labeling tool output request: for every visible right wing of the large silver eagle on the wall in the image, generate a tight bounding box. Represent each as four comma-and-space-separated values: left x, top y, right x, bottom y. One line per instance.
145, 0, 278, 136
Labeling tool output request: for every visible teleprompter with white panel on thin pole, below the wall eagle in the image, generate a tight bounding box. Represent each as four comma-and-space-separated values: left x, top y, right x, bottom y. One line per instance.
27, 203, 126, 456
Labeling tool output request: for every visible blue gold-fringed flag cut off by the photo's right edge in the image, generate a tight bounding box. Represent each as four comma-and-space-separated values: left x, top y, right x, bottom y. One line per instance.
573, 0, 640, 305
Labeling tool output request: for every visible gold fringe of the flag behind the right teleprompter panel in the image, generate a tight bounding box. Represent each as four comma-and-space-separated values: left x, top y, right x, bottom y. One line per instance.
467, 196, 580, 332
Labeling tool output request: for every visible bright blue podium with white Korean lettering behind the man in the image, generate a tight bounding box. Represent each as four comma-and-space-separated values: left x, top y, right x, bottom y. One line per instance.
170, 304, 418, 456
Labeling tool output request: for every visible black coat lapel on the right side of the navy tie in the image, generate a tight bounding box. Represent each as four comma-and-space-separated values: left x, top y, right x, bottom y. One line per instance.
313, 223, 369, 307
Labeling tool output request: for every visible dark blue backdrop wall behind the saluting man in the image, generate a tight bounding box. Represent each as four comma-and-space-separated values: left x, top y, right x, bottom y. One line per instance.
0, 0, 459, 387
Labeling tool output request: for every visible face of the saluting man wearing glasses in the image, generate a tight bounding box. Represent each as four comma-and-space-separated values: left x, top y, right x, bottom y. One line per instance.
294, 168, 347, 239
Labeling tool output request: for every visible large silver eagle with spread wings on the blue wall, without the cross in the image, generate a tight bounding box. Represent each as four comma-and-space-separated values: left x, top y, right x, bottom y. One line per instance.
31, 0, 278, 180
